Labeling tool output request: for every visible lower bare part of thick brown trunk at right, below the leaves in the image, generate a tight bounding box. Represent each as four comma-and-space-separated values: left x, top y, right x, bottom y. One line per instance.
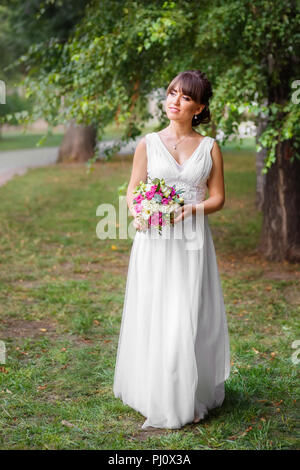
259, 141, 300, 262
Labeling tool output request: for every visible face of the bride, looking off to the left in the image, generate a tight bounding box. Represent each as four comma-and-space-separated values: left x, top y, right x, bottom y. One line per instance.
165, 85, 204, 122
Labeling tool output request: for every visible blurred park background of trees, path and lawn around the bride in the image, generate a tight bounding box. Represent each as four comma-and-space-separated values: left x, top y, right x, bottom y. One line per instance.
0, 0, 300, 449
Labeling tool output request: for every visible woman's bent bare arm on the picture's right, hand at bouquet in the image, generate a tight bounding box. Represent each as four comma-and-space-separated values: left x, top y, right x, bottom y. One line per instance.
192, 141, 225, 214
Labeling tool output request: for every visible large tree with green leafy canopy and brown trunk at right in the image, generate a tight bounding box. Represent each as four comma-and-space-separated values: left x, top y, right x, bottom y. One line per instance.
1, 0, 300, 261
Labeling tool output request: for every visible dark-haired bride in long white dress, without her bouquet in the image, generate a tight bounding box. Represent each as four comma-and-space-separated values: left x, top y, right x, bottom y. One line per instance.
113, 70, 230, 429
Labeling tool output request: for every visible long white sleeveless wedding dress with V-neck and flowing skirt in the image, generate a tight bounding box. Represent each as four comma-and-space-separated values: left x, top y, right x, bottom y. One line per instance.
113, 132, 230, 429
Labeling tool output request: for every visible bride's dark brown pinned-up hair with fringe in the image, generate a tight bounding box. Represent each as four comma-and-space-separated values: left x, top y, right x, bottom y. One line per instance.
167, 70, 213, 127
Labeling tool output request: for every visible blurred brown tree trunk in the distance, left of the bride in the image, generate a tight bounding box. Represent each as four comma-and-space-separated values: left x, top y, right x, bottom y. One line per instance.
57, 123, 97, 163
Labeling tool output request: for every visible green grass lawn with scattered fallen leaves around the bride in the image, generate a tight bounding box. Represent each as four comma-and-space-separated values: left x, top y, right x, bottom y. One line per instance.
0, 151, 300, 450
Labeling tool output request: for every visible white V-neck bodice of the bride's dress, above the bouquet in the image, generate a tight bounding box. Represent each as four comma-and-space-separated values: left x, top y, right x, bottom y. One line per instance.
146, 132, 215, 203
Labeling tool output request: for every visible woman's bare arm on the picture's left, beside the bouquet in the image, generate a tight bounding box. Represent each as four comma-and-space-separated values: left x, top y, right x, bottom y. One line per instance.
126, 137, 147, 217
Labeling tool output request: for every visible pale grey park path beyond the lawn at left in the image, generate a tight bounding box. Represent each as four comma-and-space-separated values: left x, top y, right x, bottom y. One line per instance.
0, 140, 137, 186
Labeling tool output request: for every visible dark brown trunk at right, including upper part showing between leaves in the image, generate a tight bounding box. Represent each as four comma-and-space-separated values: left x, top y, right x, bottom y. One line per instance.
258, 43, 300, 262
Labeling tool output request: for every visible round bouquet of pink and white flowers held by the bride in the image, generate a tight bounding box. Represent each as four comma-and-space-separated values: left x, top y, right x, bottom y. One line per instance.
132, 178, 184, 235
